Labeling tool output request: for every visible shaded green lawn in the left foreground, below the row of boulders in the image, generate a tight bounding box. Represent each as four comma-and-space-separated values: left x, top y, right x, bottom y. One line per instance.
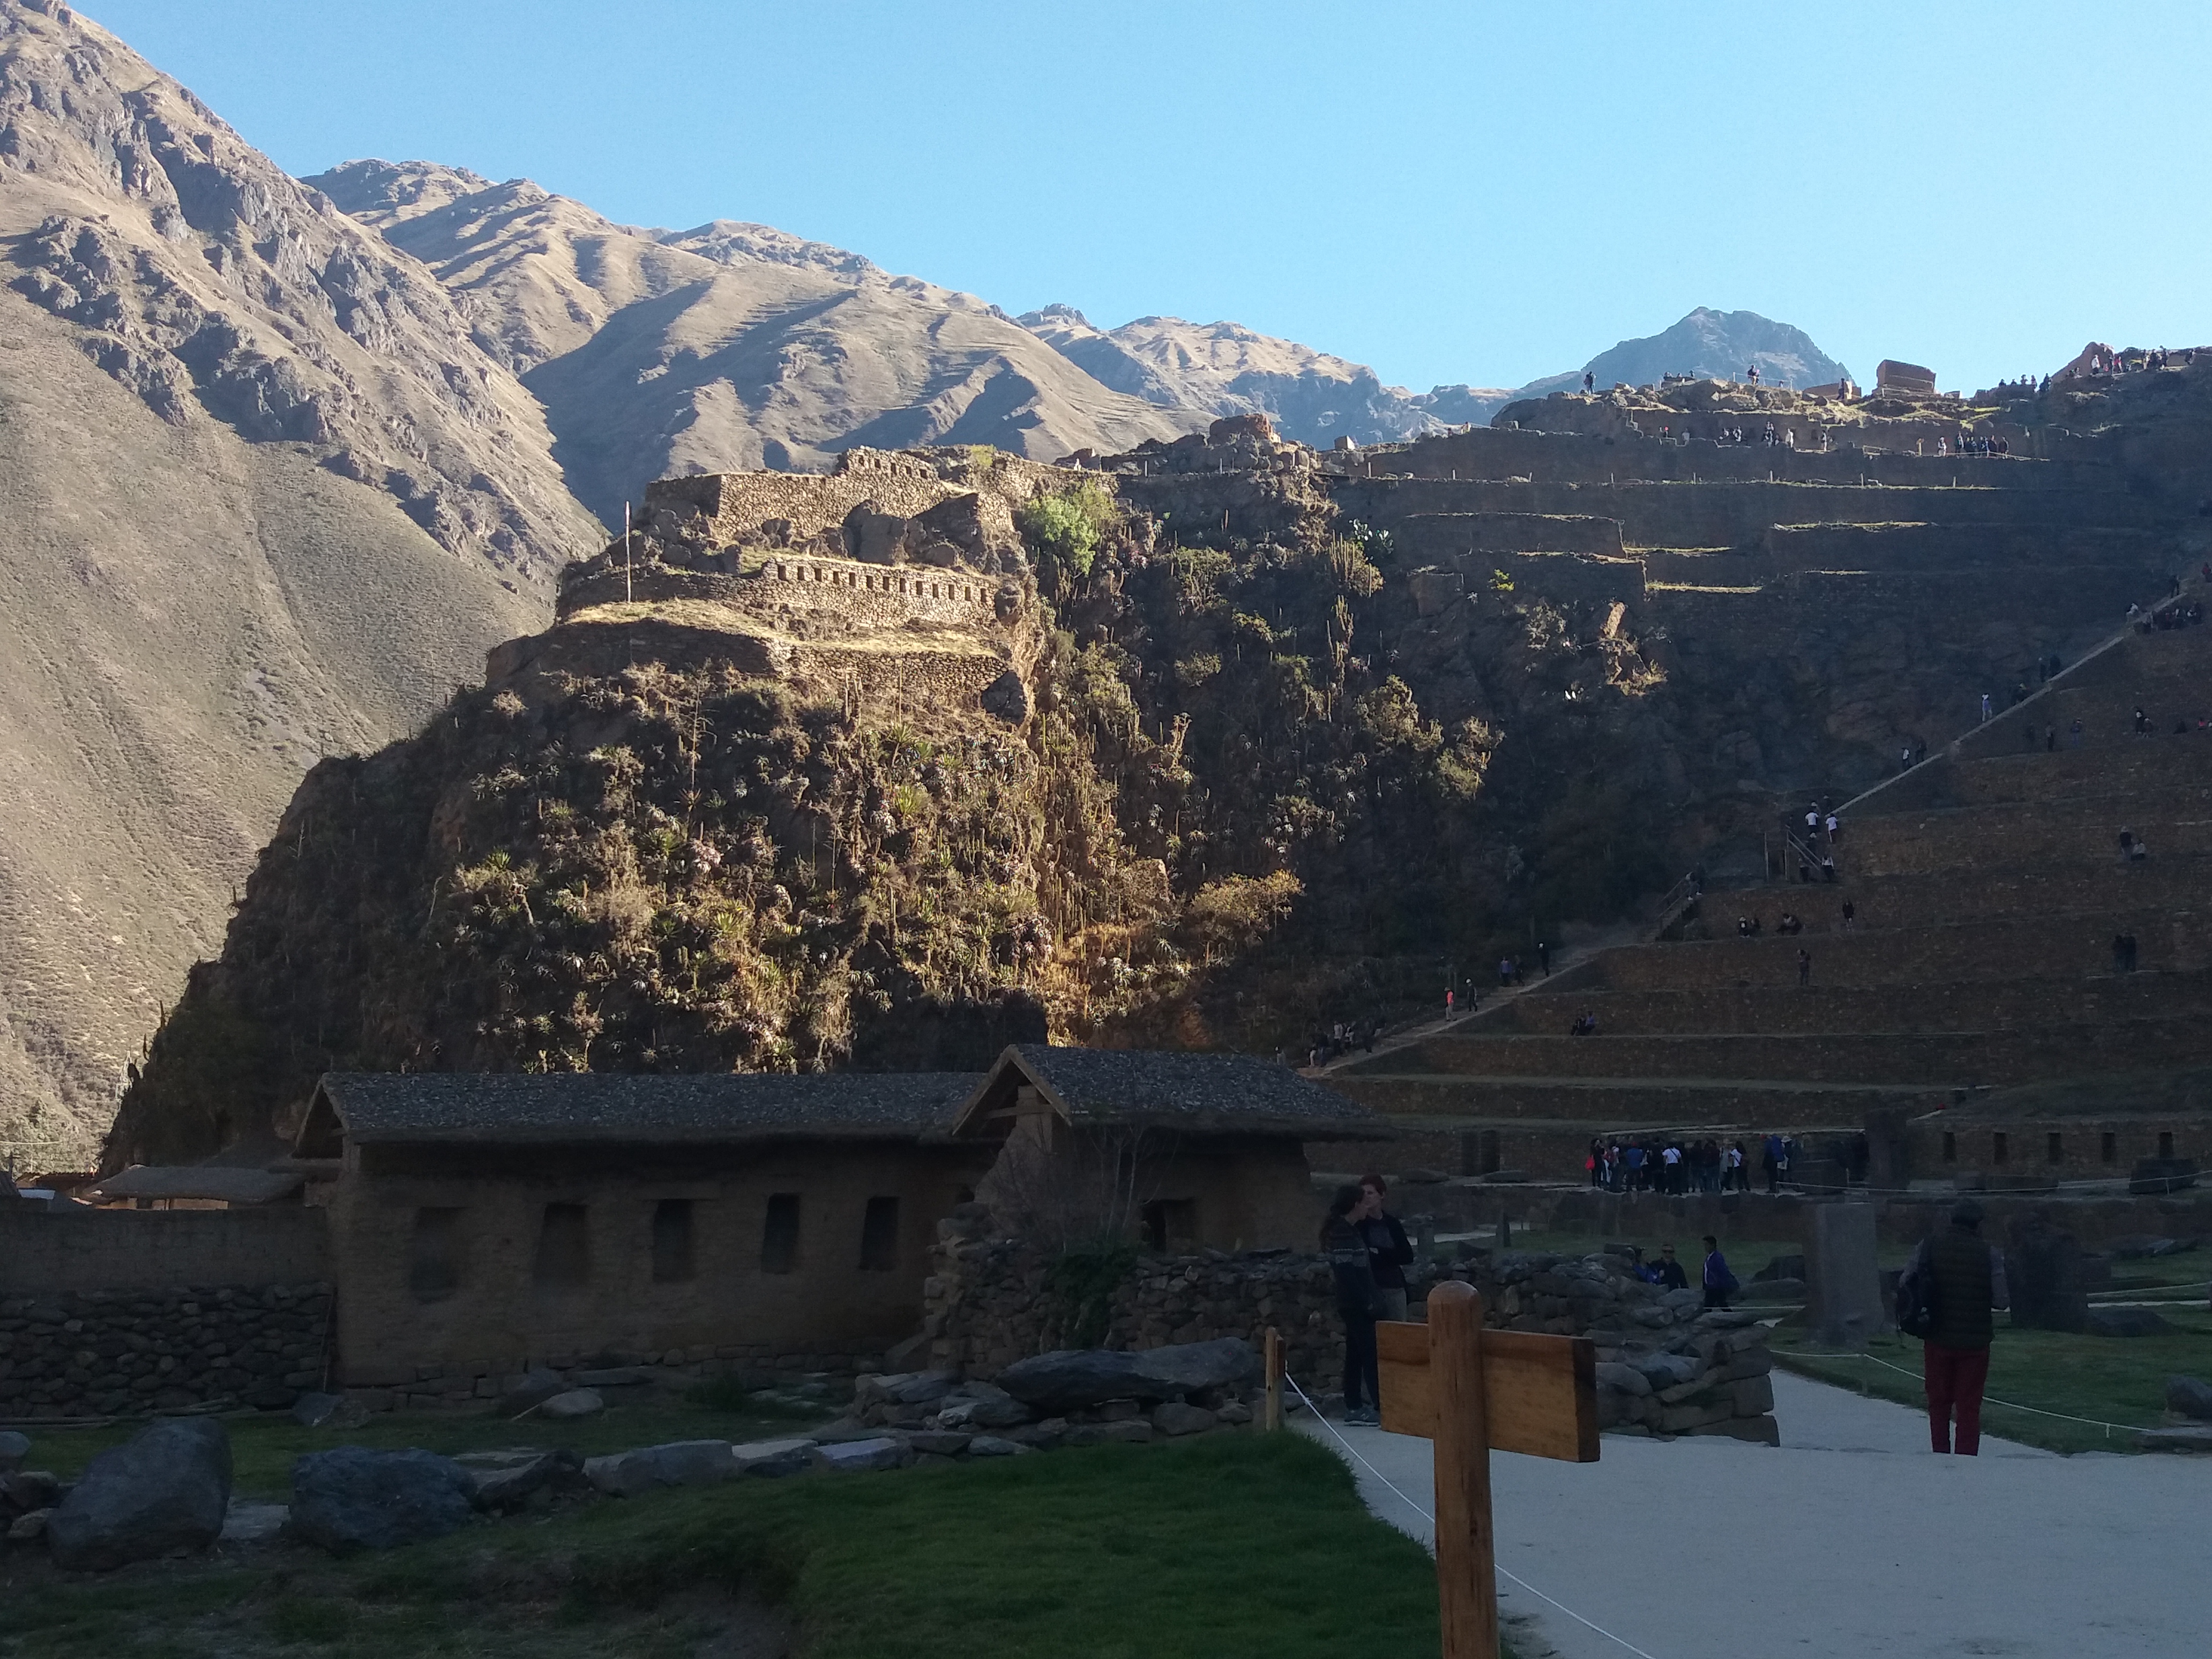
0, 1420, 1438, 1659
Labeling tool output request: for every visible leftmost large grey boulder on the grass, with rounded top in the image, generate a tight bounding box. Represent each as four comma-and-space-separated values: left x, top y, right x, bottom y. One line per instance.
47, 1418, 230, 1573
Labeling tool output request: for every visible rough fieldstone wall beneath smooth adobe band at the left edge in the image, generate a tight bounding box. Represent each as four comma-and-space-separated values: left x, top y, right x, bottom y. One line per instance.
0, 1283, 332, 1418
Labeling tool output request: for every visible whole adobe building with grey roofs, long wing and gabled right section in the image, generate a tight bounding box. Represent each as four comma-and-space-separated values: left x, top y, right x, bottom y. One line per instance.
292, 1044, 1382, 1400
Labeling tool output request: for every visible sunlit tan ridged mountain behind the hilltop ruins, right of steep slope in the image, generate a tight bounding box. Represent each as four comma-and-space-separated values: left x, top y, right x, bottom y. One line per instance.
308, 161, 1204, 522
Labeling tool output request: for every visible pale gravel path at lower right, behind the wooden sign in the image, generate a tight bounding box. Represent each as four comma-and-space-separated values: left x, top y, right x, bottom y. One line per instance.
1294, 1371, 2212, 1659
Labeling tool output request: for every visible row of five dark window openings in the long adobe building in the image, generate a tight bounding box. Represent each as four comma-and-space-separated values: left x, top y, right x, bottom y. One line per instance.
407, 1192, 898, 1303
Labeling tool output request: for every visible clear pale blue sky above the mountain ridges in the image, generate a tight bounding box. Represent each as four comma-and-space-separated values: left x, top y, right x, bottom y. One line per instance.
86, 0, 2212, 387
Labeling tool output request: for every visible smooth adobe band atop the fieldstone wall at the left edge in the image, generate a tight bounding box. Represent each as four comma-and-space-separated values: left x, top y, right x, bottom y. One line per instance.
0, 1204, 330, 1296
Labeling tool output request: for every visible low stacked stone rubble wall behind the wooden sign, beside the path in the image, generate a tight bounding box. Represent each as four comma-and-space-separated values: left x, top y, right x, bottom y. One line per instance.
1473, 1252, 1781, 1447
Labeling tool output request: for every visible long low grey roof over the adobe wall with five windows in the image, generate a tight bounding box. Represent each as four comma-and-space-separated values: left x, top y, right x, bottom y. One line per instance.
298, 1071, 982, 1155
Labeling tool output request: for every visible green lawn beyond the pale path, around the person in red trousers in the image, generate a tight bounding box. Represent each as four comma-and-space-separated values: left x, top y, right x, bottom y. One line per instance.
1774, 1305, 2212, 1451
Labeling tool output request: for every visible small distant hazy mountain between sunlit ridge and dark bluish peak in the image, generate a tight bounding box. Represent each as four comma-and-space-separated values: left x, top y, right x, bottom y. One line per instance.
1020, 305, 1513, 447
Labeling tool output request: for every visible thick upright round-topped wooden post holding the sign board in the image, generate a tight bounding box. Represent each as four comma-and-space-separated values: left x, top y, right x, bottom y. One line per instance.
1429, 1279, 1498, 1659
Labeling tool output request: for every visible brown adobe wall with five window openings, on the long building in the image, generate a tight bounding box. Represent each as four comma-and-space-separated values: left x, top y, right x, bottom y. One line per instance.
330, 1144, 980, 1398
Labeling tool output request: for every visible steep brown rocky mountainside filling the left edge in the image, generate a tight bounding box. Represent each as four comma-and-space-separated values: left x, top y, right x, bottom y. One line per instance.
0, 0, 597, 1163
